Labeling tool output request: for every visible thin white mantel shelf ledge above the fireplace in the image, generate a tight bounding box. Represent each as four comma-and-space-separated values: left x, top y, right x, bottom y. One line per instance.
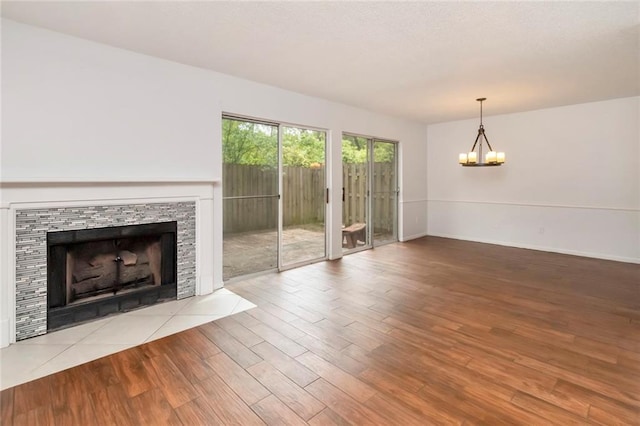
0, 177, 221, 185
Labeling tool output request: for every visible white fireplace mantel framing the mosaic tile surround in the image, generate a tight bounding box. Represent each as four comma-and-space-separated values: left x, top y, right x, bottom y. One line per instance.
0, 177, 222, 347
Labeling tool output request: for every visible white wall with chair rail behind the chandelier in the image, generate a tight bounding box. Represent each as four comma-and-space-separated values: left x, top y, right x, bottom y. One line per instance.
427, 97, 640, 262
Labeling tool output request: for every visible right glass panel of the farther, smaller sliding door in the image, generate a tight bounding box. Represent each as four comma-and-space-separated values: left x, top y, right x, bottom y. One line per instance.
371, 140, 398, 246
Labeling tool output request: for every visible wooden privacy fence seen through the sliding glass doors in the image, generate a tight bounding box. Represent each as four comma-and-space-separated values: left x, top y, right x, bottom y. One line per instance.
223, 163, 396, 233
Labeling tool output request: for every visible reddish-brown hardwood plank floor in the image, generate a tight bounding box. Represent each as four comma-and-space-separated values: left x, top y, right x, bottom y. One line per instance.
0, 237, 640, 425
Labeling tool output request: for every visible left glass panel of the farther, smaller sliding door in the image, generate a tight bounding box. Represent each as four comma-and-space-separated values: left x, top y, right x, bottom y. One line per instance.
342, 135, 371, 251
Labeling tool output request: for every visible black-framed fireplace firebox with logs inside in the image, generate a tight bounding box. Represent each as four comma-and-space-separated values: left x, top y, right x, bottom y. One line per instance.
47, 222, 177, 330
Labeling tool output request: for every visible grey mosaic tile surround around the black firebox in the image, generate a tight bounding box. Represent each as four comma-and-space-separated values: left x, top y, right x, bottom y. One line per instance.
15, 201, 196, 340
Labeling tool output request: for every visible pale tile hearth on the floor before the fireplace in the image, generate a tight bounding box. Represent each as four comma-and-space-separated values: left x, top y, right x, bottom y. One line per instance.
0, 288, 256, 390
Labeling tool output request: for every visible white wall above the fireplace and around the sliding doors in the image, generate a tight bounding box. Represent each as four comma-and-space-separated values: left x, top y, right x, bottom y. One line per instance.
0, 19, 427, 344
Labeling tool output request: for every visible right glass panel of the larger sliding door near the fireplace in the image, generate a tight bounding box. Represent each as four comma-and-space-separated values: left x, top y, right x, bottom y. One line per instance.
281, 126, 326, 267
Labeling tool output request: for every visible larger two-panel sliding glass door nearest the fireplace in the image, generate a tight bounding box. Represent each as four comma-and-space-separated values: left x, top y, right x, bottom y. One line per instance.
222, 116, 326, 280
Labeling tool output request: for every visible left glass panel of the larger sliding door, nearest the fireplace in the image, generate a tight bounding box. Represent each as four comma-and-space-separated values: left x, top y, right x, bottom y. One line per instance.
222, 117, 278, 280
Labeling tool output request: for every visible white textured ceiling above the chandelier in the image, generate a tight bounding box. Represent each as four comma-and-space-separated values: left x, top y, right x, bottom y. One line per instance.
2, 1, 640, 123
